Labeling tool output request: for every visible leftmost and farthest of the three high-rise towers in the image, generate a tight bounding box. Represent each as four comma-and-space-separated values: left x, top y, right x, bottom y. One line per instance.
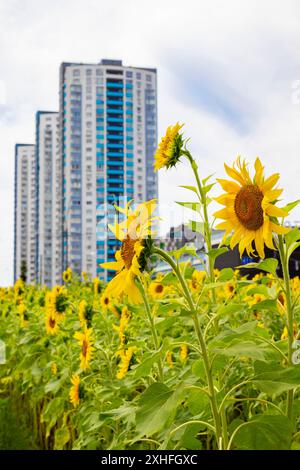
14, 144, 37, 283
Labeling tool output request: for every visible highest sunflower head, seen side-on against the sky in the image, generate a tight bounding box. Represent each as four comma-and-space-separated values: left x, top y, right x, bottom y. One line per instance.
154, 123, 184, 171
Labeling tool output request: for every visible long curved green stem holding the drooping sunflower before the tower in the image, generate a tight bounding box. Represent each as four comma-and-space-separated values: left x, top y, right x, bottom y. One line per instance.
154, 248, 222, 448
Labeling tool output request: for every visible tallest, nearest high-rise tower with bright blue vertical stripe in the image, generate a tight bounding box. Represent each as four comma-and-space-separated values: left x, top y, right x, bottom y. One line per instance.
59, 60, 158, 279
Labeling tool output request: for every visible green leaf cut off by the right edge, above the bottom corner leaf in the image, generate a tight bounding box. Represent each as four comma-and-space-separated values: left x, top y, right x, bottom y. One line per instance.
253, 364, 300, 395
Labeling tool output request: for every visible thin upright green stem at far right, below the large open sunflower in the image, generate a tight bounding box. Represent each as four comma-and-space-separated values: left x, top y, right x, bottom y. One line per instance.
278, 235, 294, 419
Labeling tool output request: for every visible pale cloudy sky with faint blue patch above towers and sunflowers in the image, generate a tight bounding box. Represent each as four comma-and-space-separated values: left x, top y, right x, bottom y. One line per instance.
0, 0, 300, 286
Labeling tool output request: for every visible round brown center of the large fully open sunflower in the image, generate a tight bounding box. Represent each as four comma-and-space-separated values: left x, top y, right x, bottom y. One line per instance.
234, 184, 264, 230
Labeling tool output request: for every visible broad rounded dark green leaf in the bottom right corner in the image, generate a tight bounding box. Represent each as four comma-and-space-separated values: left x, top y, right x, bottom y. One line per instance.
233, 415, 293, 450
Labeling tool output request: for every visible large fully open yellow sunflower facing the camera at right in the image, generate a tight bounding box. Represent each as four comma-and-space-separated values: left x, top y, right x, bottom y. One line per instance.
214, 157, 289, 258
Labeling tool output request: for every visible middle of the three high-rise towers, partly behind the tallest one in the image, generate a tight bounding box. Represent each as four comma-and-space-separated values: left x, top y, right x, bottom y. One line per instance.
36, 111, 62, 286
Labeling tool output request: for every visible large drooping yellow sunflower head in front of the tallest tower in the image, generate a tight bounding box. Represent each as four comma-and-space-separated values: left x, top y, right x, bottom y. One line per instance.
101, 200, 156, 303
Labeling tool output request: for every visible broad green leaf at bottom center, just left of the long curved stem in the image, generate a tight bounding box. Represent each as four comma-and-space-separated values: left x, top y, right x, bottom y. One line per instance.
136, 382, 183, 437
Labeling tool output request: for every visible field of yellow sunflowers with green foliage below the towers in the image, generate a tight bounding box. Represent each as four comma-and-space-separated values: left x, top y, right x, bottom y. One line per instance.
0, 124, 300, 450
